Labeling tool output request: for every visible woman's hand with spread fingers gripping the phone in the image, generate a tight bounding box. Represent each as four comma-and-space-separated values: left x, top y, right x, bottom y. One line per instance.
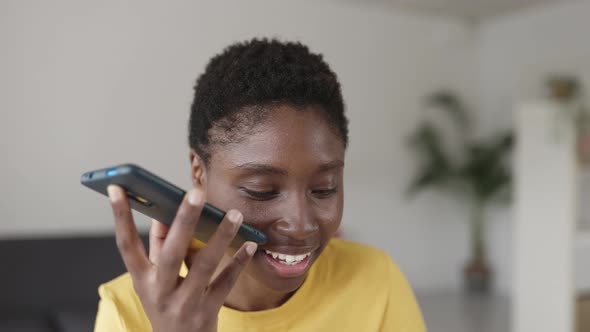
108, 185, 256, 332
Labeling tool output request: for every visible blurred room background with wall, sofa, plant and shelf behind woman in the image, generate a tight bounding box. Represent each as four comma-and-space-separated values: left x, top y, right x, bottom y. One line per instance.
0, 0, 590, 332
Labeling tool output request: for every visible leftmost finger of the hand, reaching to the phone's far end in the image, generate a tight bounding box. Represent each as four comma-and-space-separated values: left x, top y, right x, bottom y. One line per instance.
107, 185, 150, 277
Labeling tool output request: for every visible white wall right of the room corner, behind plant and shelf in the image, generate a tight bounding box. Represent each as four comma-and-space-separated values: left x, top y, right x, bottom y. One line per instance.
478, 1, 590, 291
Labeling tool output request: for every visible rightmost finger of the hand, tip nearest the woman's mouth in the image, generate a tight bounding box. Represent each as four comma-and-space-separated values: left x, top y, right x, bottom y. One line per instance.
209, 241, 258, 308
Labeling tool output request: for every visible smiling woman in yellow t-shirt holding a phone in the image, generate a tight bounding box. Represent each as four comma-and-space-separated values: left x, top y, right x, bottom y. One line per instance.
95, 39, 425, 332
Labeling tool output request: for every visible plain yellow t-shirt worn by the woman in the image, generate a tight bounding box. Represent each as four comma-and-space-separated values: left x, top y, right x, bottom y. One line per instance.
95, 239, 426, 332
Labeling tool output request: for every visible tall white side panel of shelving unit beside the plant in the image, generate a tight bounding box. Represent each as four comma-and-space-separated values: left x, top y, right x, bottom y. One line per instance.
512, 100, 590, 332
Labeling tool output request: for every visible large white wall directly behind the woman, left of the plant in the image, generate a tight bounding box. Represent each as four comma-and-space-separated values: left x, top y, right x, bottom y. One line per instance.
0, 0, 477, 290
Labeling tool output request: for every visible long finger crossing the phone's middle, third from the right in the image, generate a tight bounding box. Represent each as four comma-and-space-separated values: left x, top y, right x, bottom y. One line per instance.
157, 189, 205, 289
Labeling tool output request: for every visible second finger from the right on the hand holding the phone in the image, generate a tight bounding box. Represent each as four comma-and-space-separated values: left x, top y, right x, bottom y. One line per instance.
181, 210, 243, 294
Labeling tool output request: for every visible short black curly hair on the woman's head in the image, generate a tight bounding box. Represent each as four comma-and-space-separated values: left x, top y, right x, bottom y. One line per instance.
189, 39, 348, 164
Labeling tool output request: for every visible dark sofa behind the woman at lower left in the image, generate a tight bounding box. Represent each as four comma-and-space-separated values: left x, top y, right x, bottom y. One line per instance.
0, 236, 146, 332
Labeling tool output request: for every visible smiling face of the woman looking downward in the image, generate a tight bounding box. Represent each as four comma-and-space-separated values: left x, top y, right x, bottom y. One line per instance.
193, 106, 344, 292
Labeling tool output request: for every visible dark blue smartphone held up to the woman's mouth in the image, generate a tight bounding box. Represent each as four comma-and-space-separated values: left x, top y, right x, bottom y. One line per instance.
80, 164, 267, 249
